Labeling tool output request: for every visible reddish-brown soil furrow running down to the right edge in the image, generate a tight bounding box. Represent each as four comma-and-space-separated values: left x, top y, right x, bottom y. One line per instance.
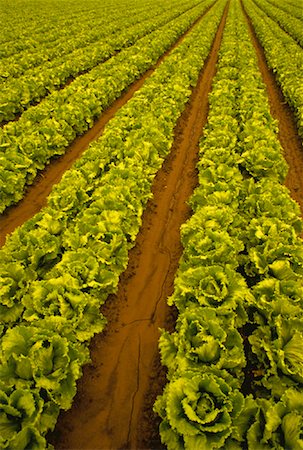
241, 1, 303, 216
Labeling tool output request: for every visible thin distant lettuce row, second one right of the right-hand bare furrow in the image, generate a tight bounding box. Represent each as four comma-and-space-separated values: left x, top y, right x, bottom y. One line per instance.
254, 0, 303, 47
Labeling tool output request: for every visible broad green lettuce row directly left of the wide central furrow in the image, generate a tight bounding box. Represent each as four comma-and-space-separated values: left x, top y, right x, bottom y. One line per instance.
0, 0, 226, 450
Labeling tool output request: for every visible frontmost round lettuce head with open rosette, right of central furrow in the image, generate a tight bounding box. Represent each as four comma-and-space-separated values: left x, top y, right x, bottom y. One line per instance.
154, 371, 244, 450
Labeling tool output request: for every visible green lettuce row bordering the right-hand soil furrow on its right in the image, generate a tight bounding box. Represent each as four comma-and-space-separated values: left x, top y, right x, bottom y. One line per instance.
243, 0, 303, 137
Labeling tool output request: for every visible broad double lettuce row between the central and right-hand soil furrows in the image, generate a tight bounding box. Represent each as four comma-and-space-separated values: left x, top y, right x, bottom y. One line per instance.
154, 0, 303, 450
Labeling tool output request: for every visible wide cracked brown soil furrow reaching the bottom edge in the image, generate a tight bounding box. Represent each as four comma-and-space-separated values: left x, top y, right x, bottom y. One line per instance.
50, 6, 228, 450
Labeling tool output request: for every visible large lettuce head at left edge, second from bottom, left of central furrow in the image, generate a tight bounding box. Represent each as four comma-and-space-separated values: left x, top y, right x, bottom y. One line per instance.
0, 325, 89, 409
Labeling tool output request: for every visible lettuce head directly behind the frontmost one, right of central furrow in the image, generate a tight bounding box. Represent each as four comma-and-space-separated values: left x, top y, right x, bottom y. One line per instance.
159, 307, 246, 381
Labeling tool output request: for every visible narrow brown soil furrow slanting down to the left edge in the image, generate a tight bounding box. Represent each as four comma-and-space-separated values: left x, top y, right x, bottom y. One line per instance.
0, 1, 216, 247
